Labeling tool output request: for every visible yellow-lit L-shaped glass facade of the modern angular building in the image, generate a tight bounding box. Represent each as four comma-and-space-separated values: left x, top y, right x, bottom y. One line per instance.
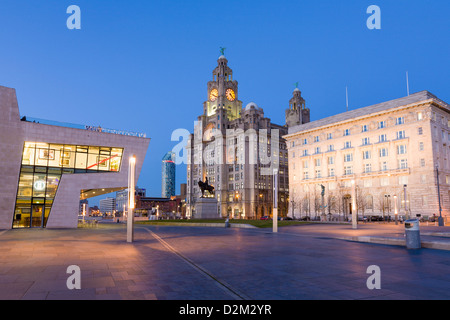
13, 142, 123, 228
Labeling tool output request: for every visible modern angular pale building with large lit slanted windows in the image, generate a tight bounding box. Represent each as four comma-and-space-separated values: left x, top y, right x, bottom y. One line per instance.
0, 86, 150, 229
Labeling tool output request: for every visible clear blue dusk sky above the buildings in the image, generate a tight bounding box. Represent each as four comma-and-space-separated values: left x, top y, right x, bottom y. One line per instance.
0, 0, 450, 204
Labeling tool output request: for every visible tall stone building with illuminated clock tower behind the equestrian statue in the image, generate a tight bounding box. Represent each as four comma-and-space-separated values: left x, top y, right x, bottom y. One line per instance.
186, 55, 309, 219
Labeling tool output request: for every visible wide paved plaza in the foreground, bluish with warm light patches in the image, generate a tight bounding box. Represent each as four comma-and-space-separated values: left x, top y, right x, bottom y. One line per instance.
0, 224, 450, 301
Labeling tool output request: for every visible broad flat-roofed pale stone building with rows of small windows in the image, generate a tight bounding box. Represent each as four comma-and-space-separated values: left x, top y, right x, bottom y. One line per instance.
284, 91, 450, 218
